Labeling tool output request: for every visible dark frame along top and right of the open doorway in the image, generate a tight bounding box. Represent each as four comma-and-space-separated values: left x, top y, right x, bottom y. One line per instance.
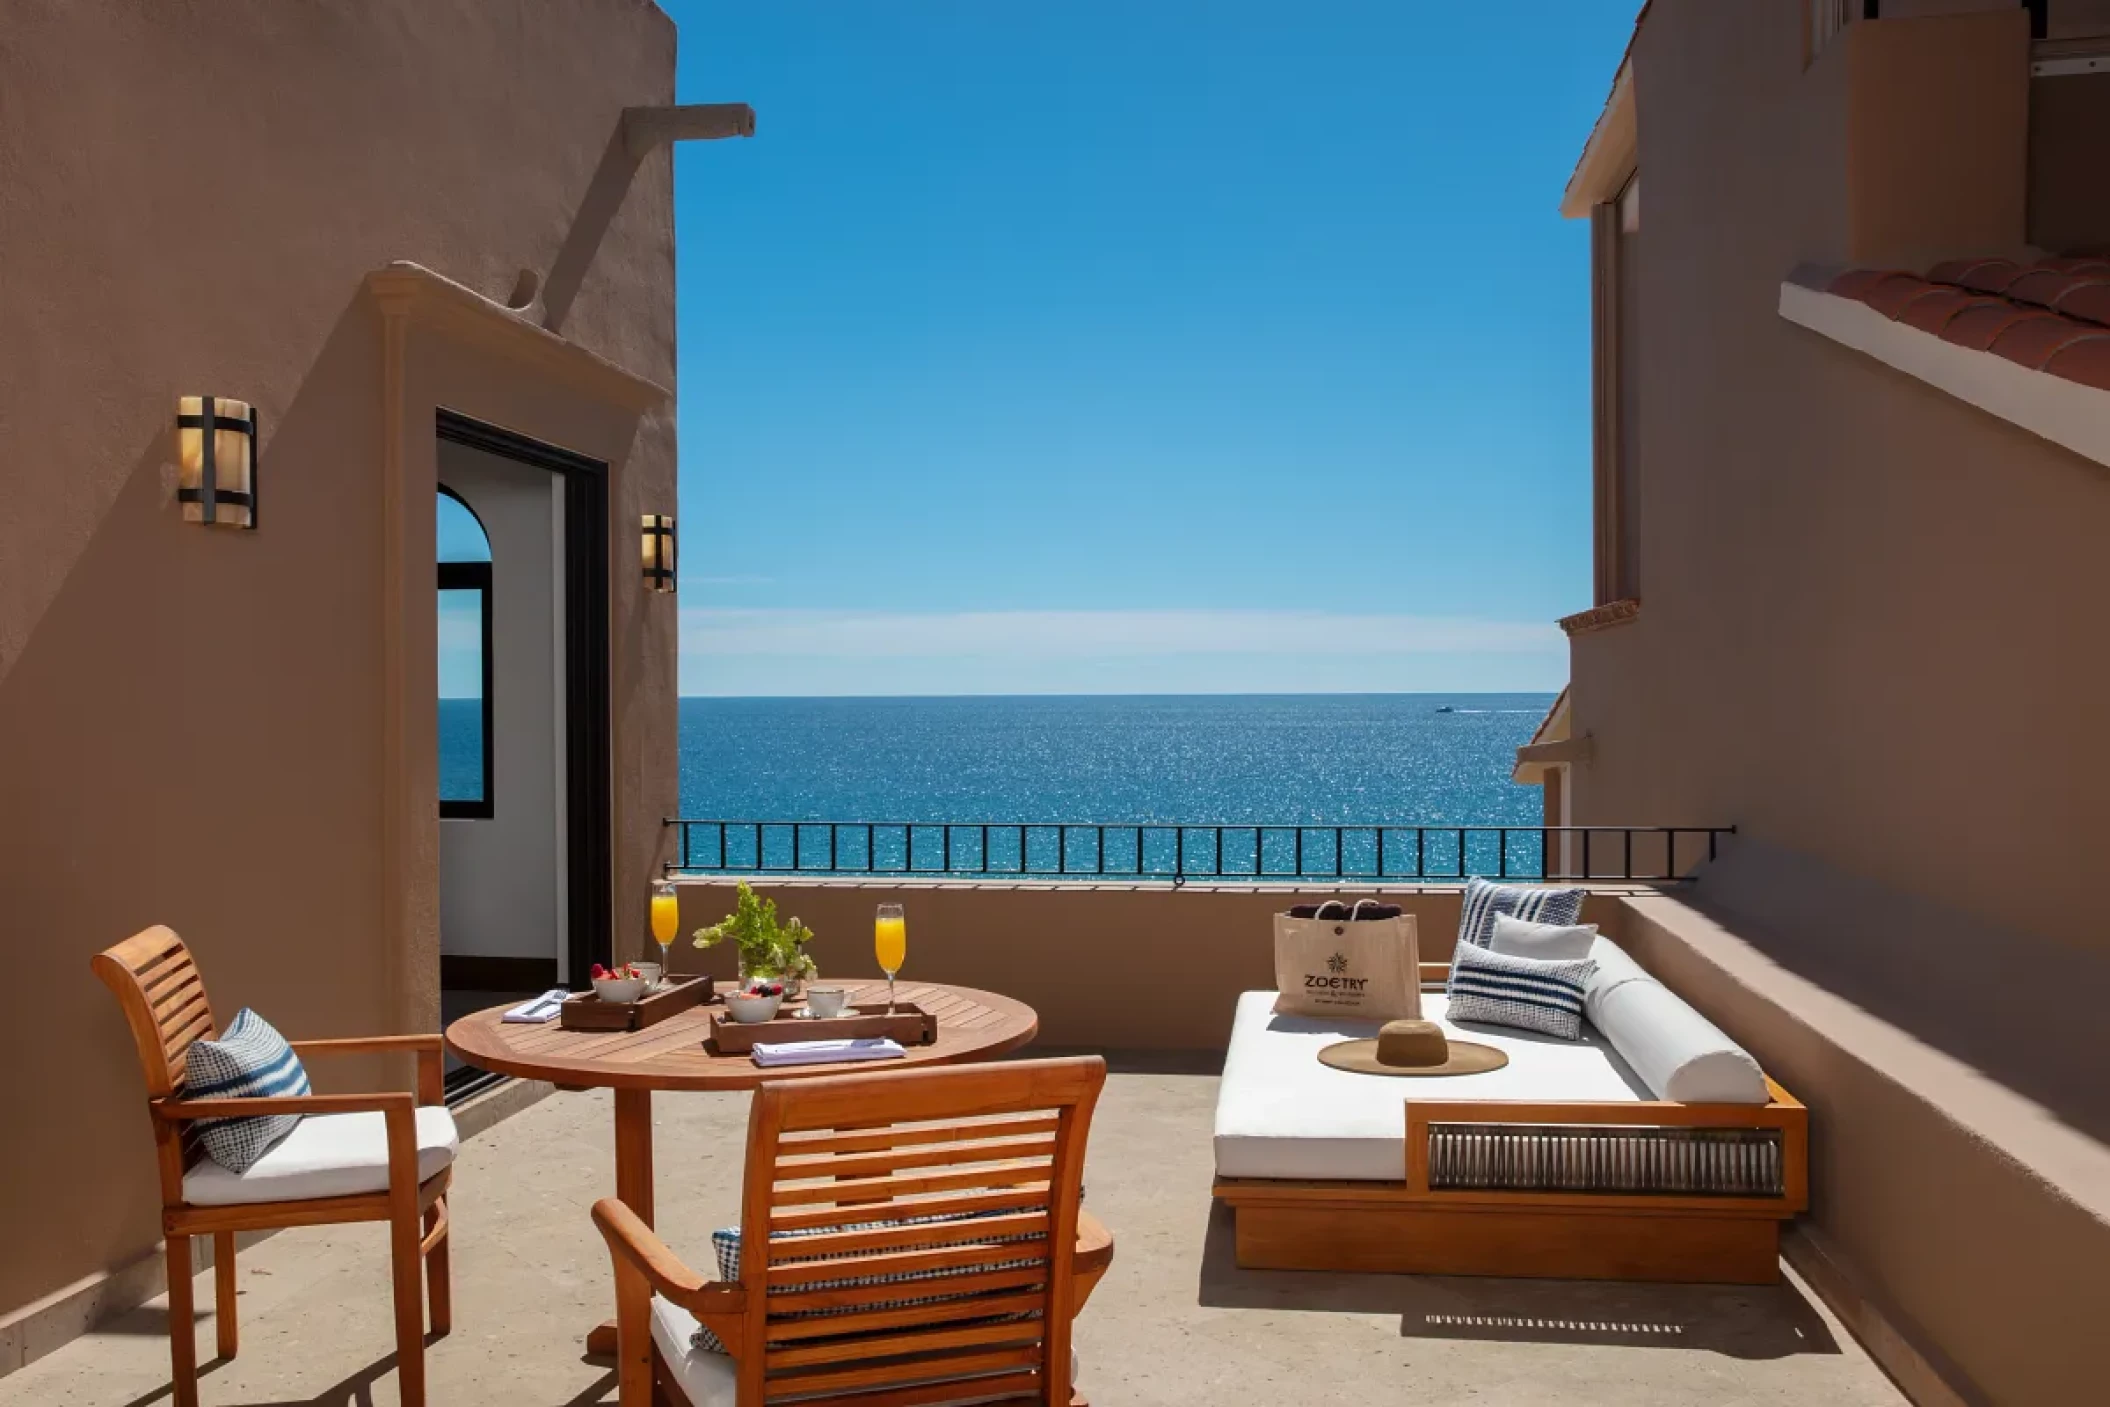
435, 407, 614, 989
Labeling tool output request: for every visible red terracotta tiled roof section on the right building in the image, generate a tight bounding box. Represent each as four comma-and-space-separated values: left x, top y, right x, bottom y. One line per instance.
1825, 255, 2110, 390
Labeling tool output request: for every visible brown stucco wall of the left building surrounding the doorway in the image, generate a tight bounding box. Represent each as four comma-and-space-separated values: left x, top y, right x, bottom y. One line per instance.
0, 0, 675, 1314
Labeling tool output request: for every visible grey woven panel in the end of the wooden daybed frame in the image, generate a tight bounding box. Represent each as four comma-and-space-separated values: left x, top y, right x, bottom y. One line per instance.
1428, 1124, 1783, 1196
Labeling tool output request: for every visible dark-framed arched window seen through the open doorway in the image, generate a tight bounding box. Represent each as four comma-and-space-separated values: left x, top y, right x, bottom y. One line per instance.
439, 489, 494, 821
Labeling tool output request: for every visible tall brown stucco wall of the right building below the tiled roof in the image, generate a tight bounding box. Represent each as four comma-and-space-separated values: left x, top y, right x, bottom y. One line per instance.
1572, 2, 2110, 947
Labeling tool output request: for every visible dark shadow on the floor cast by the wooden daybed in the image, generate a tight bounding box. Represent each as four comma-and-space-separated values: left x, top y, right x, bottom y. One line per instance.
1198, 1207, 1840, 1358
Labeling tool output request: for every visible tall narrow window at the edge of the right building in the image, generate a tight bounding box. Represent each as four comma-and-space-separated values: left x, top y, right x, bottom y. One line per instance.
1591, 173, 1642, 605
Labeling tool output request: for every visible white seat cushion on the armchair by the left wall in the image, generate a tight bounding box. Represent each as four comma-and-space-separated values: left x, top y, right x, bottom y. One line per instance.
184, 1105, 460, 1207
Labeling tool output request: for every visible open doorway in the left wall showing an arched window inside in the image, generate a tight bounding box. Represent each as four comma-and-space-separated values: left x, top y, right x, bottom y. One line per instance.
435, 409, 612, 1088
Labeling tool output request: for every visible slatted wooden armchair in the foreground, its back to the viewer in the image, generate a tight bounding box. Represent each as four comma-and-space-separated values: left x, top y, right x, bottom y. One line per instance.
593, 1057, 1114, 1407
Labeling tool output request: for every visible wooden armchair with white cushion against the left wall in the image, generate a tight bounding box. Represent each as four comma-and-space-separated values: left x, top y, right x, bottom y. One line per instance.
93, 926, 456, 1407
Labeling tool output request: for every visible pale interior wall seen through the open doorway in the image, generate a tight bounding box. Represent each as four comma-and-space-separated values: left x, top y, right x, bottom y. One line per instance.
439, 443, 565, 964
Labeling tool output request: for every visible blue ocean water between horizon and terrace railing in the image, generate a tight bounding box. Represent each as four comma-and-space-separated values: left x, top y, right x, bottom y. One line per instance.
441, 694, 1553, 869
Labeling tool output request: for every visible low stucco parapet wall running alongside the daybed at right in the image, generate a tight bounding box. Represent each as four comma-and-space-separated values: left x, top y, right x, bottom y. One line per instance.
1625, 881, 2110, 1407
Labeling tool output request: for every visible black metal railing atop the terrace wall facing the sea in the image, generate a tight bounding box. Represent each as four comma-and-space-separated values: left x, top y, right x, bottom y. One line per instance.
665, 818, 1737, 884
